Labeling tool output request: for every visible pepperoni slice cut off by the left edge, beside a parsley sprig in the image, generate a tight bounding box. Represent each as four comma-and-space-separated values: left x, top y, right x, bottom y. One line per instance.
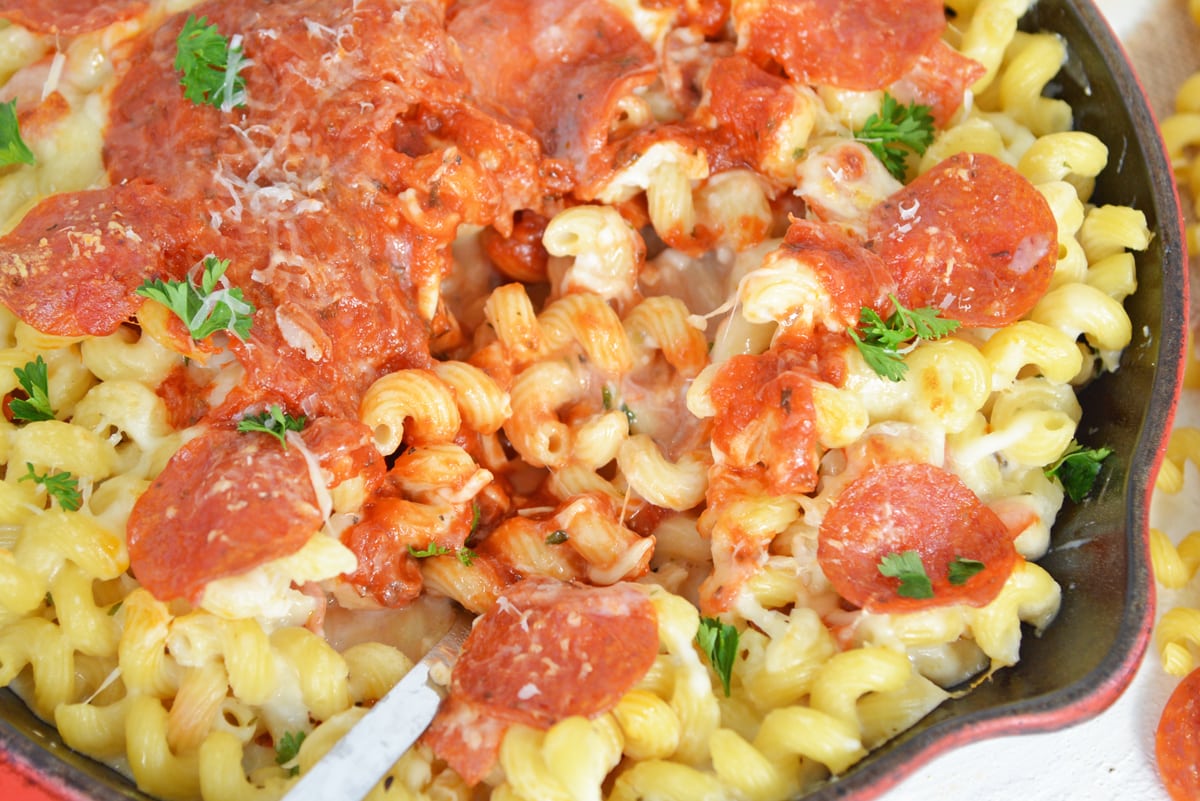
0, 182, 197, 337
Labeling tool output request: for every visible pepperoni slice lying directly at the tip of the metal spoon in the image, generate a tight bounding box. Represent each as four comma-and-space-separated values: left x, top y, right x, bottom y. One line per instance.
425, 578, 659, 784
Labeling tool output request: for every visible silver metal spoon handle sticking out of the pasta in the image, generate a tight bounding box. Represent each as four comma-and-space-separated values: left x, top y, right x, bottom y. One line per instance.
286, 620, 470, 801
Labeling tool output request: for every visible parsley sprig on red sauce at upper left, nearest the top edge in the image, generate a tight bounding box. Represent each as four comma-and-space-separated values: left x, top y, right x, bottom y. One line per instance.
175, 14, 250, 112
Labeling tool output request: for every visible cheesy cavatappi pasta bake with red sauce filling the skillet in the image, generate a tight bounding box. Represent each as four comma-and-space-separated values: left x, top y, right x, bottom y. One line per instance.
0, 0, 1147, 801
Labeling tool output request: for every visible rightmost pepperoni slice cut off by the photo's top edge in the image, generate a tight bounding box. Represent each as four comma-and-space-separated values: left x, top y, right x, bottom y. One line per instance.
738, 0, 946, 90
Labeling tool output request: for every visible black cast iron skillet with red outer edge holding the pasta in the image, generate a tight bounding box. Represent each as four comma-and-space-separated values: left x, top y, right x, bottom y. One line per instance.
0, 0, 1188, 801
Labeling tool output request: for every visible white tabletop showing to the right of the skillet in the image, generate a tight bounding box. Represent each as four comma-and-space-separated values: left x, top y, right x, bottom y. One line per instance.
881, 0, 1200, 801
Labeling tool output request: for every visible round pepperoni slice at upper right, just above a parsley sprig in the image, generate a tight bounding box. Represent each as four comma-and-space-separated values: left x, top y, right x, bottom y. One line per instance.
868, 153, 1058, 327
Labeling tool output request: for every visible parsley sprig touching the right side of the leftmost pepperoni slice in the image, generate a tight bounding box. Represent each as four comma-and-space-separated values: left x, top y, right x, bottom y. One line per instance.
137, 255, 254, 342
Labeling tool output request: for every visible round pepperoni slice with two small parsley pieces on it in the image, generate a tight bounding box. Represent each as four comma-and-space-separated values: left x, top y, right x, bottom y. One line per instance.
817, 462, 1018, 613
